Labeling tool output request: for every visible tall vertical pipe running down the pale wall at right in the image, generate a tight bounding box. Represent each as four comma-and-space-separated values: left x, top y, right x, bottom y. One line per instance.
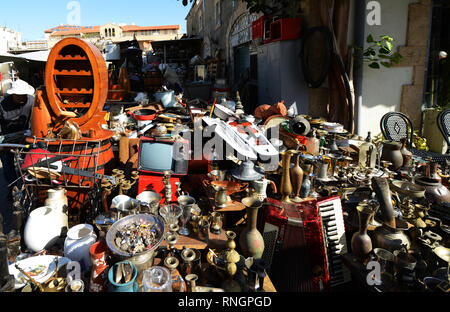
353, 0, 366, 135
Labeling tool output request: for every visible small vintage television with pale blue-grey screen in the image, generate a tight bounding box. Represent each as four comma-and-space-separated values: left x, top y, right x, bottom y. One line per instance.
139, 141, 187, 174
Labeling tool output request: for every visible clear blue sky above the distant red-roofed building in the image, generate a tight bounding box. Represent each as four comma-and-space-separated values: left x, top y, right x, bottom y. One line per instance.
0, 0, 190, 41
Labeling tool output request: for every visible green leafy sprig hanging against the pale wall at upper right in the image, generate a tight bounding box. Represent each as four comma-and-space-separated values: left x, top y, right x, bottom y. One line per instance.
355, 35, 402, 69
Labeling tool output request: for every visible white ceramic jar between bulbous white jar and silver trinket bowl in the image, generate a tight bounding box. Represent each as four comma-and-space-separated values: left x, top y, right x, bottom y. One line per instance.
64, 224, 97, 271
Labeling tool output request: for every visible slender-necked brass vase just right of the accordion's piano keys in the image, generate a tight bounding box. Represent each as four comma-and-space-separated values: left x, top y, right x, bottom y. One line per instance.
351, 204, 374, 258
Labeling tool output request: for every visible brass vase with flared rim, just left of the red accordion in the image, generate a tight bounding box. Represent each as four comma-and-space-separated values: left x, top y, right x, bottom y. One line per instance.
239, 197, 264, 259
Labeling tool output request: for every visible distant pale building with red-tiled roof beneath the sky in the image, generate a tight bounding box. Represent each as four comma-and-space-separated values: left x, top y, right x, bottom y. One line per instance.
45, 23, 182, 51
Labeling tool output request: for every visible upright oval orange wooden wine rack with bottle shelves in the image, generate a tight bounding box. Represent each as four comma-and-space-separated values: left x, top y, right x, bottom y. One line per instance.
45, 38, 108, 127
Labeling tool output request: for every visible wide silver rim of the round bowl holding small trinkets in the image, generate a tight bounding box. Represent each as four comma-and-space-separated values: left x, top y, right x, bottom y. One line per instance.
106, 214, 165, 258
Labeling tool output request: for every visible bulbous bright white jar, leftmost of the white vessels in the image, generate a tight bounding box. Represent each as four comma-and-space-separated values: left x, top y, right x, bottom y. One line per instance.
24, 207, 61, 252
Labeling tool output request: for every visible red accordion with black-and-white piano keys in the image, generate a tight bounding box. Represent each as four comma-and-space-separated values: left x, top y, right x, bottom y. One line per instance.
258, 196, 351, 292
